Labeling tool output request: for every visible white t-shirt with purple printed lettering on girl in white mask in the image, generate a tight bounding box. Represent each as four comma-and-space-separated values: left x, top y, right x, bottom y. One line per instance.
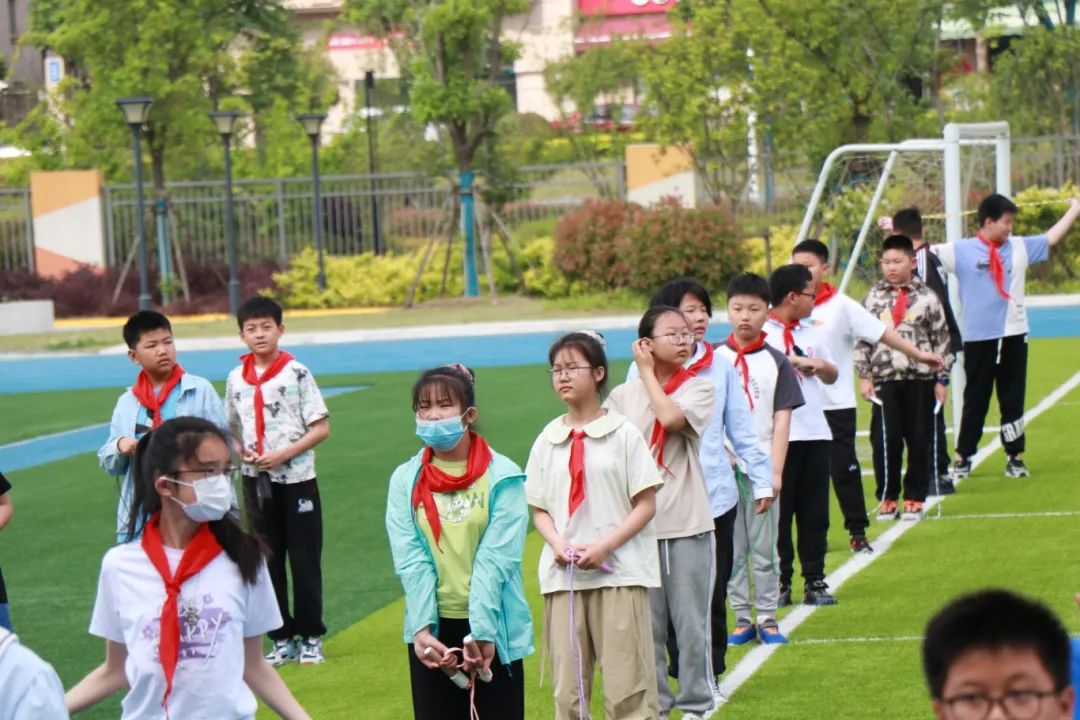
90, 542, 282, 720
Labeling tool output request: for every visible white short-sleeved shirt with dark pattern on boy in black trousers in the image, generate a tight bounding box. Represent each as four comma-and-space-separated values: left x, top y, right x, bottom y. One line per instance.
225, 359, 329, 485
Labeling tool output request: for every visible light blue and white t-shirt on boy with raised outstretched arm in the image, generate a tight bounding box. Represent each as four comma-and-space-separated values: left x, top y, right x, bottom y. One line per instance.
931, 235, 1050, 342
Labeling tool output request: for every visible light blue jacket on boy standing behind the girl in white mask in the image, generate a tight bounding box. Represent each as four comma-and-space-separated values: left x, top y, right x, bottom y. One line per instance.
97, 372, 229, 542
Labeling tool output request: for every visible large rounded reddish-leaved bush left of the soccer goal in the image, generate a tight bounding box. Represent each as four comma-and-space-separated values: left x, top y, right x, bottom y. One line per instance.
555, 198, 750, 293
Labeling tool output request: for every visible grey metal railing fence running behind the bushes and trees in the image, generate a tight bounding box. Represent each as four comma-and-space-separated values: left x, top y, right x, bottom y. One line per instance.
0, 136, 1080, 270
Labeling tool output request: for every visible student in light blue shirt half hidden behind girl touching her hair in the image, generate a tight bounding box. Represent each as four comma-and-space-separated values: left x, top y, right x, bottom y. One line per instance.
626, 277, 778, 690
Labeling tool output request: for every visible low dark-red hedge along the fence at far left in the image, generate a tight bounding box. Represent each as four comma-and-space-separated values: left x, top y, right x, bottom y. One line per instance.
0, 260, 281, 317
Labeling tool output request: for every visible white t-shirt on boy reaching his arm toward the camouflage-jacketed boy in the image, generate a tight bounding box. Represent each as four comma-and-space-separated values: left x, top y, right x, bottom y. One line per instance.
812, 293, 886, 410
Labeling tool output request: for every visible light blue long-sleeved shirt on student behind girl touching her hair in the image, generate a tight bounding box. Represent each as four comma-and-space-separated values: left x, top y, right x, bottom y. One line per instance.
626, 342, 772, 517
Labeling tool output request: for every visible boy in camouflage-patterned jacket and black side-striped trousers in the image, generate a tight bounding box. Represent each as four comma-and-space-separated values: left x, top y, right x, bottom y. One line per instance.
854, 235, 953, 520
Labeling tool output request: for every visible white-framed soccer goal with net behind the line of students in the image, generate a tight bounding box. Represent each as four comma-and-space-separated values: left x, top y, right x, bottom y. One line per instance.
796, 122, 1012, 436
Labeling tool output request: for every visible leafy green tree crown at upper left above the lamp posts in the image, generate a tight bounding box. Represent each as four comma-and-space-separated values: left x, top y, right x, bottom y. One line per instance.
15, 0, 313, 195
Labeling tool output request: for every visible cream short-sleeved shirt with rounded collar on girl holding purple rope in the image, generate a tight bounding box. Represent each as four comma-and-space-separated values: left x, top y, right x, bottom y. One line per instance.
525, 410, 663, 595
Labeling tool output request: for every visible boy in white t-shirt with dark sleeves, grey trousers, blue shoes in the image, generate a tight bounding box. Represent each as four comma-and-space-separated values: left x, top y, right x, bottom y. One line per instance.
717, 273, 804, 646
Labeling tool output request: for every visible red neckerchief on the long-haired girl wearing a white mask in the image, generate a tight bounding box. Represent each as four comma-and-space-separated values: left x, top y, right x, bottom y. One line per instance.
140, 513, 221, 718
